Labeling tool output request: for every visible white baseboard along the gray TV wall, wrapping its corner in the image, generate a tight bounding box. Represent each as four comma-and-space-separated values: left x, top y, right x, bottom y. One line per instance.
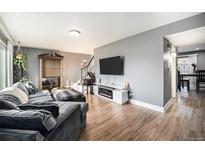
129, 99, 173, 113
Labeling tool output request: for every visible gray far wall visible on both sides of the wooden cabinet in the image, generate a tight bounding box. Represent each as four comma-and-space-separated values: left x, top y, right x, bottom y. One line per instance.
22, 47, 91, 87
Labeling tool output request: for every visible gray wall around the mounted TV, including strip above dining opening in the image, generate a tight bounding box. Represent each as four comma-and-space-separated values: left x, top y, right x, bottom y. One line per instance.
94, 13, 205, 107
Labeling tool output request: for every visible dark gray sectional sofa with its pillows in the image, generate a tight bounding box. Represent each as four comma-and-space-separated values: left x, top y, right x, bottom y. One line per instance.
0, 82, 88, 141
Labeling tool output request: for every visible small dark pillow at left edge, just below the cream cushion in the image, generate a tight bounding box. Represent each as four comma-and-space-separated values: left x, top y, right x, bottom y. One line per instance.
0, 94, 21, 110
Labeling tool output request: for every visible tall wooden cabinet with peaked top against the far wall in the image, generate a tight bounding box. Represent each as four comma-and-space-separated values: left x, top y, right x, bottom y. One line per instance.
38, 52, 64, 90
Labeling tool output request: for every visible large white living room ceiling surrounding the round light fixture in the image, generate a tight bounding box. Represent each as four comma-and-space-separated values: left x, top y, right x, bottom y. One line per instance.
0, 12, 198, 54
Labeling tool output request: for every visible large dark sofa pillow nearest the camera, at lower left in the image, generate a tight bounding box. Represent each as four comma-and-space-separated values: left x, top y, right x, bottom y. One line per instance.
0, 109, 56, 136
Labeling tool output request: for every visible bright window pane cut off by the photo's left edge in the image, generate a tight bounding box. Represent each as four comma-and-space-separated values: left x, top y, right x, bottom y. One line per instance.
0, 43, 6, 90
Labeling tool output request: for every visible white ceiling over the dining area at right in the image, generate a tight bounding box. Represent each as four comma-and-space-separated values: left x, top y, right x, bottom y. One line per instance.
166, 27, 205, 47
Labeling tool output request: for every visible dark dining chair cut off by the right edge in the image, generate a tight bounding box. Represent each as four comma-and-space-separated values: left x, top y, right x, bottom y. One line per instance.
196, 70, 205, 93
